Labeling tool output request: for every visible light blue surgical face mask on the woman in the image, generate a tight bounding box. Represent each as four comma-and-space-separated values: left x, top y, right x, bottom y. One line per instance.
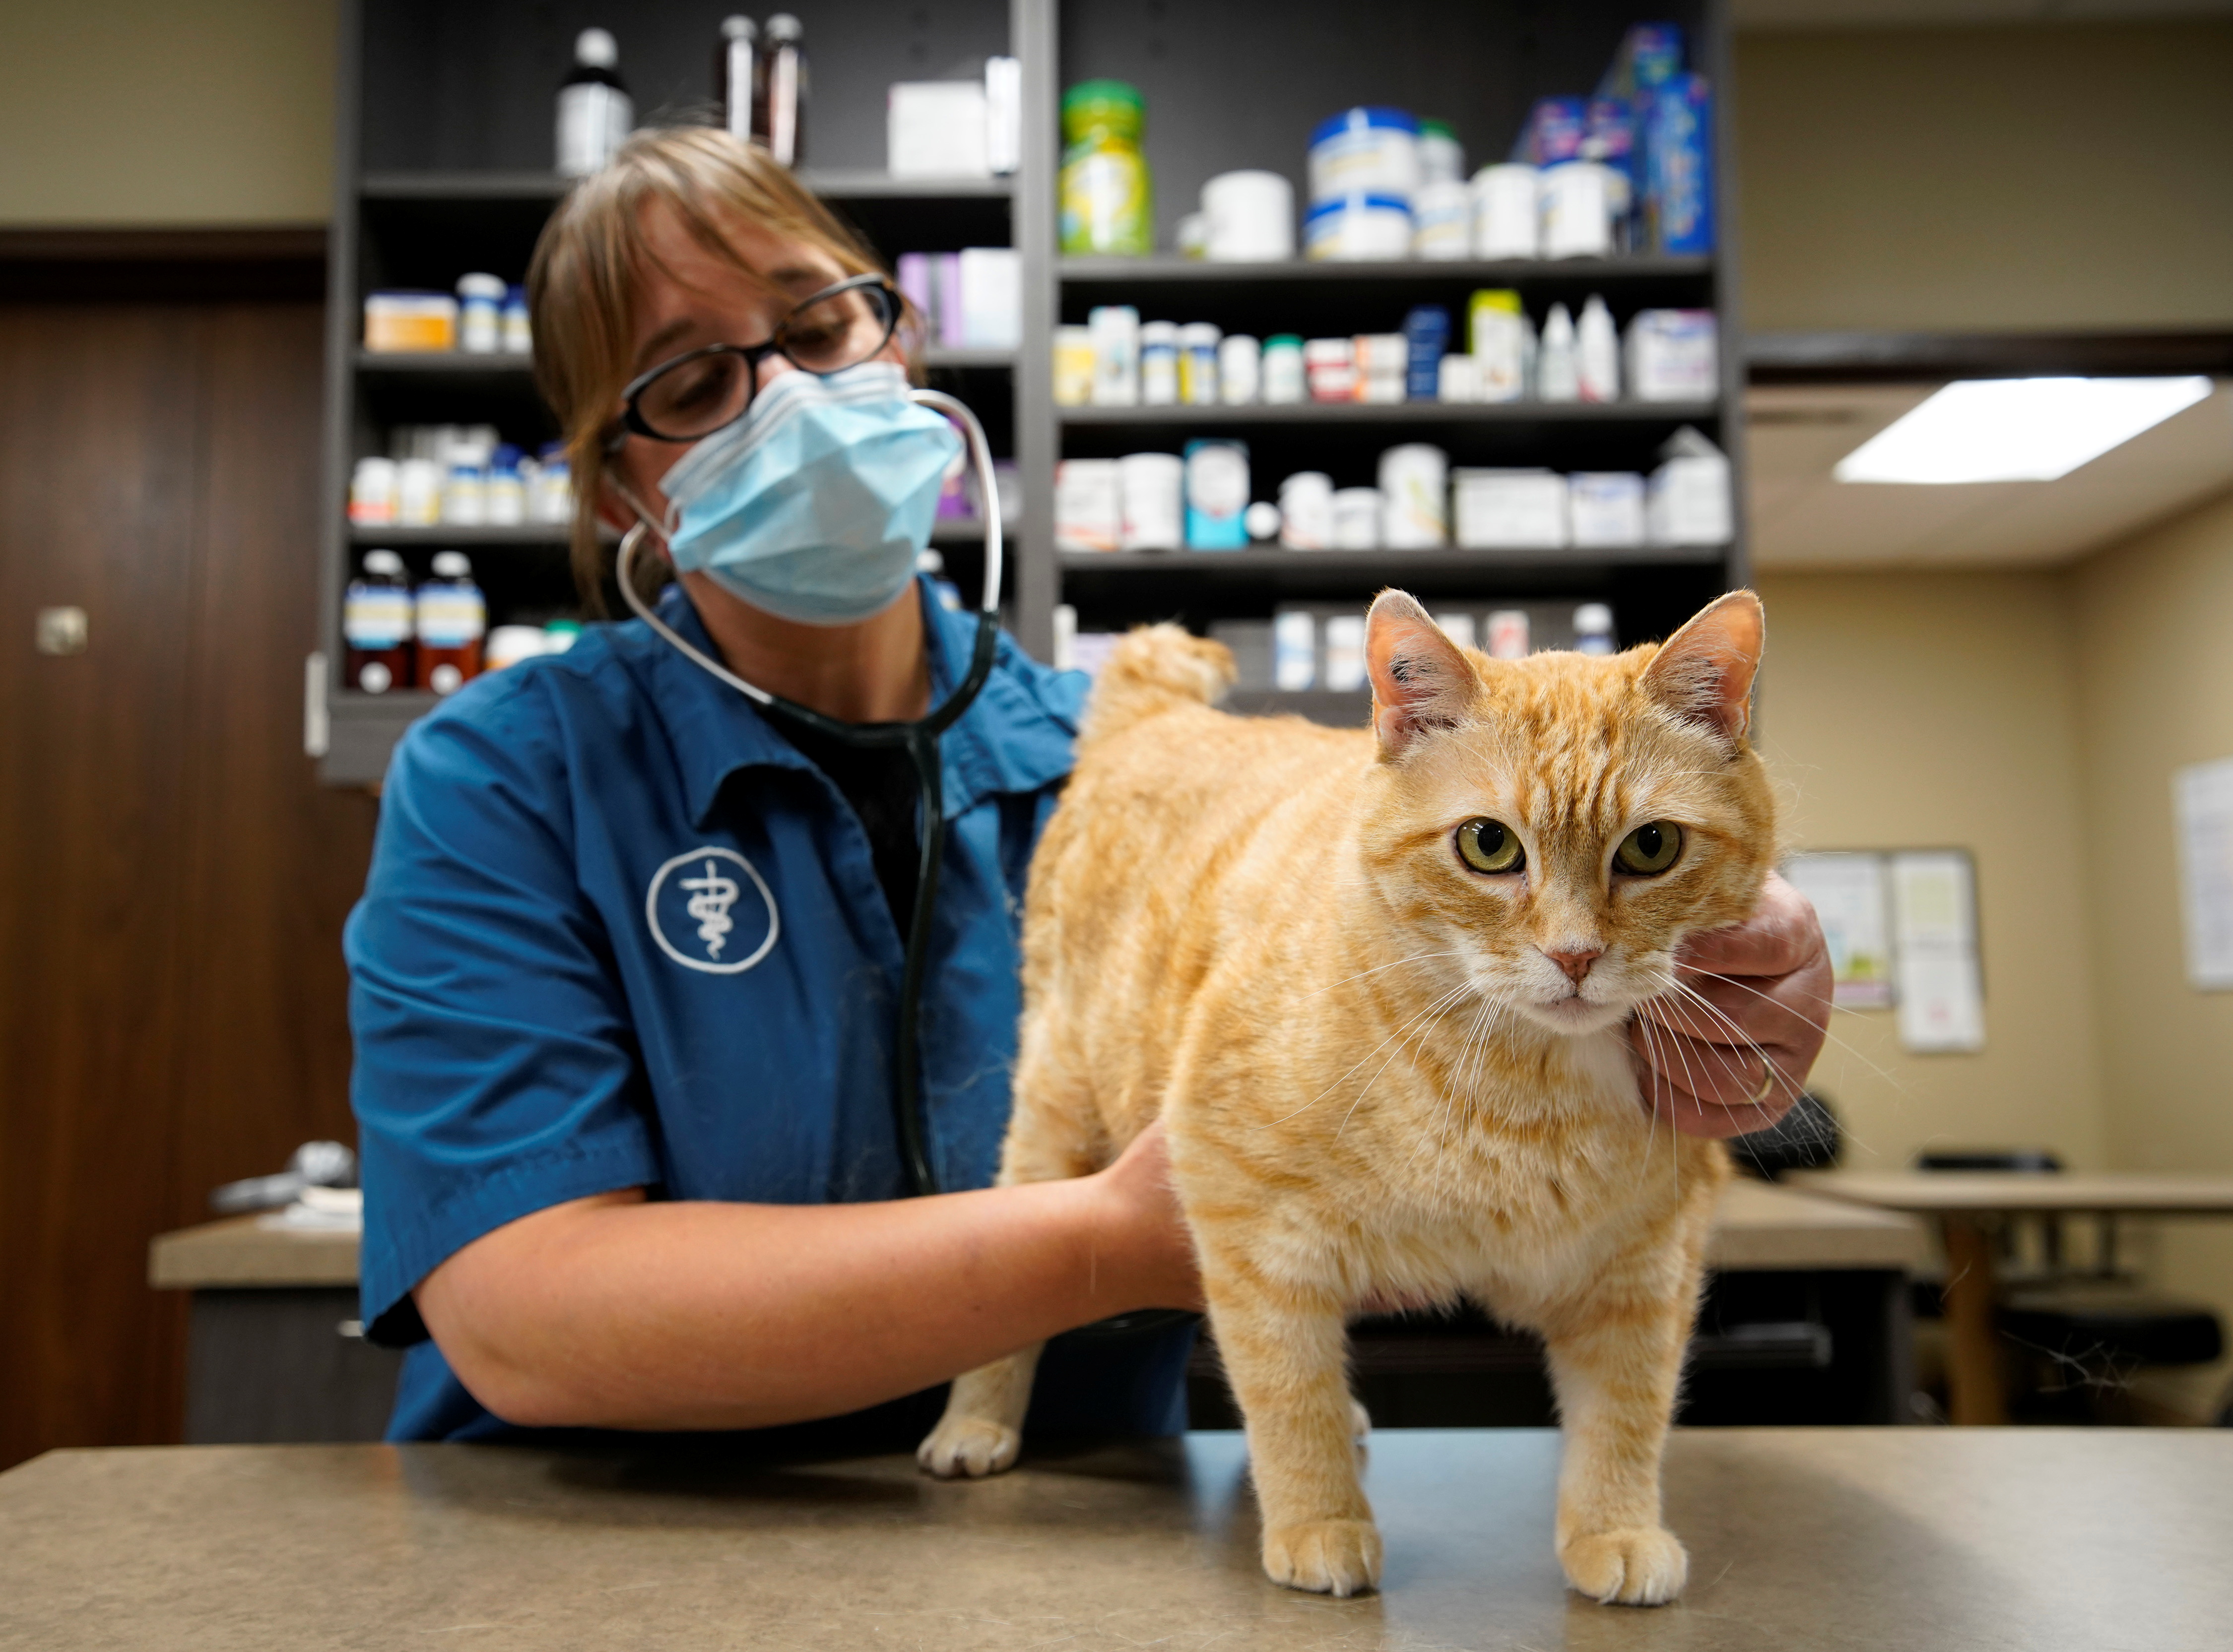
659, 362, 963, 625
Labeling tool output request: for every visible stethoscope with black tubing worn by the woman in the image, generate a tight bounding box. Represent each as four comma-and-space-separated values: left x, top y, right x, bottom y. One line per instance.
616, 388, 1000, 1195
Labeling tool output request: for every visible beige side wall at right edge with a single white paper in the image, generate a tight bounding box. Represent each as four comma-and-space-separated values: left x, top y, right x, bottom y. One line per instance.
2070, 496, 2233, 1400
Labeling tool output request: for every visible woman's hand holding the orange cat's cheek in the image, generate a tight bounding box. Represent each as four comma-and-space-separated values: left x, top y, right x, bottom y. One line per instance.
1628, 873, 1831, 1137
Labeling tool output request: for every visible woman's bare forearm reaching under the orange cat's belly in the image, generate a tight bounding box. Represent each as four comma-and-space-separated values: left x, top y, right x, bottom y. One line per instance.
415, 1154, 1192, 1429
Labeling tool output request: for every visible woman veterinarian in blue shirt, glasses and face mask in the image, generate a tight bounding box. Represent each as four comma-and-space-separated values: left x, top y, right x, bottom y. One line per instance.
346, 129, 1829, 1449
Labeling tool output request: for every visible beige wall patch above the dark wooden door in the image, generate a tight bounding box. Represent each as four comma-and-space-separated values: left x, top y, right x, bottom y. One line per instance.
0, 0, 337, 226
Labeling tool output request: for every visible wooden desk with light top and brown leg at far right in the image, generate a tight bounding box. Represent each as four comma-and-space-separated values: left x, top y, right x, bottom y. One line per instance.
1791, 1170, 2233, 1429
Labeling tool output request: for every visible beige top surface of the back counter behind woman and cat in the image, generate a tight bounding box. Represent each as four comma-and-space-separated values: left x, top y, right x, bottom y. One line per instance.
147, 1179, 1925, 1290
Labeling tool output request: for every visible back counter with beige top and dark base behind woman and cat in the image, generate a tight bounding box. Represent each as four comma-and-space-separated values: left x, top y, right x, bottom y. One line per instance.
147, 1179, 1929, 1445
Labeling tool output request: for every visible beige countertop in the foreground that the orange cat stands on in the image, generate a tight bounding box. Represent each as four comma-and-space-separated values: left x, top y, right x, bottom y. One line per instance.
0, 1429, 2233, 1652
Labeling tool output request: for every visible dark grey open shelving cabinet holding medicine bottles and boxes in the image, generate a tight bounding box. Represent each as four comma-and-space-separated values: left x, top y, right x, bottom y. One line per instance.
313, 0, 1746, 784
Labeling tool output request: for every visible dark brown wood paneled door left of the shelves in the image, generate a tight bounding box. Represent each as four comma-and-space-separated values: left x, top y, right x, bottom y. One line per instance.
0, 271, 375, 1467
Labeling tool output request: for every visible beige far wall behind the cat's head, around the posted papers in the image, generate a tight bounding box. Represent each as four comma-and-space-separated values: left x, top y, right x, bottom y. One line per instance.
1760, 574, 2106, 1168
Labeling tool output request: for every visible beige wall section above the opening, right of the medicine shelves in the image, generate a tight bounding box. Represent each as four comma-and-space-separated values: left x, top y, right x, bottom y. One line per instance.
1735, 20, 2233, 330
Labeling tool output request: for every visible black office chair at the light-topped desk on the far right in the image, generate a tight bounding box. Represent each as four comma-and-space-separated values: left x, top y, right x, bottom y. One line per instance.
1916, 1147, 2224, 1418
